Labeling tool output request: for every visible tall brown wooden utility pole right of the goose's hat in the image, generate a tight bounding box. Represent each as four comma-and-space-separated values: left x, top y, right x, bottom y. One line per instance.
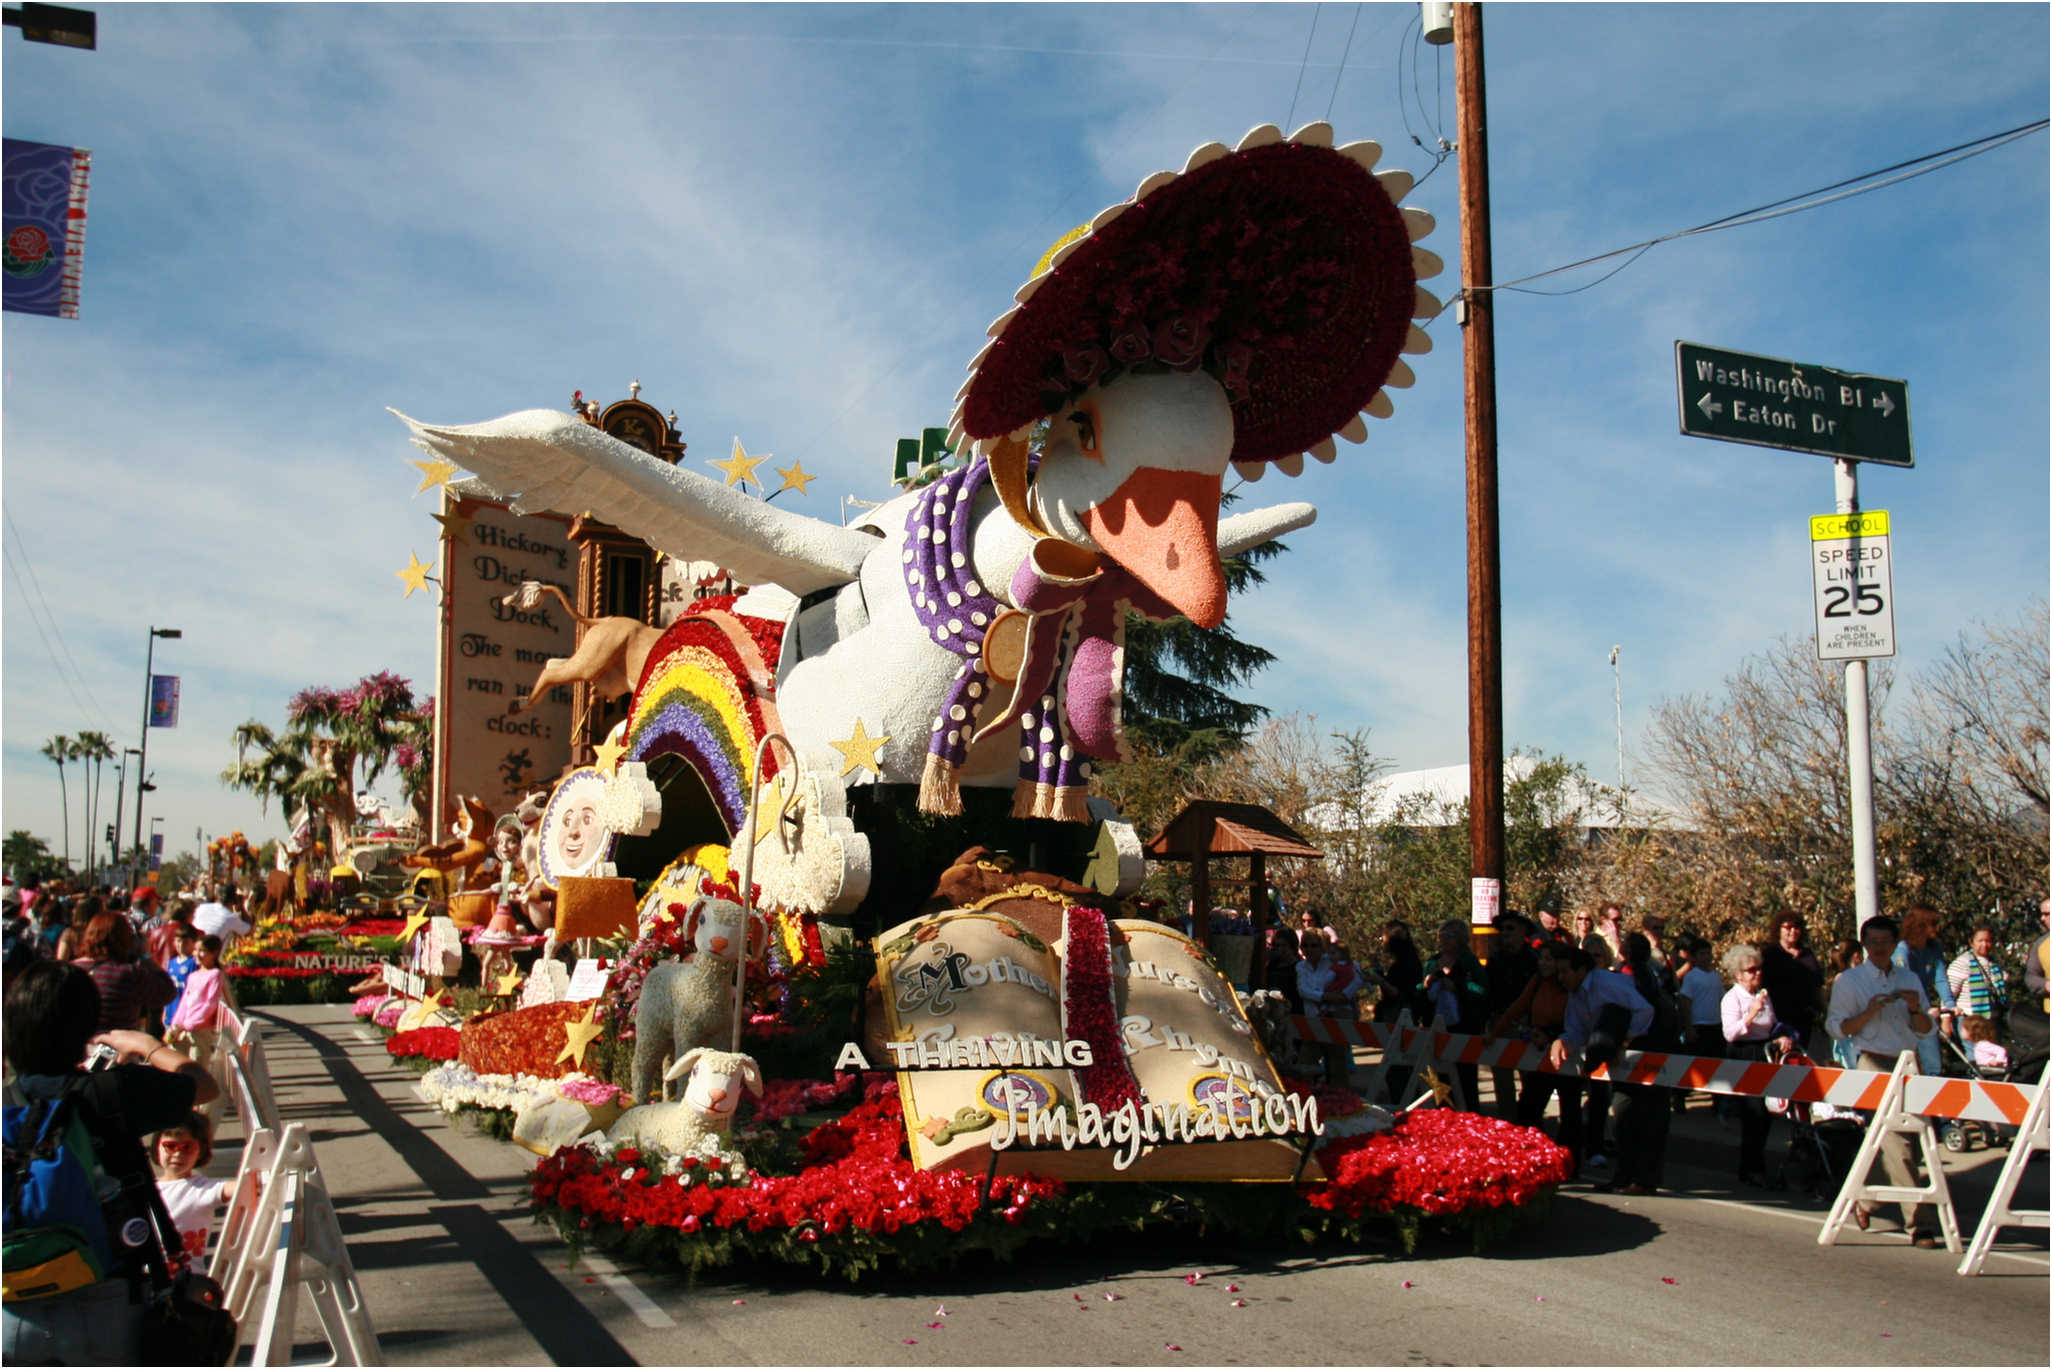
1453, 4, 1504, 930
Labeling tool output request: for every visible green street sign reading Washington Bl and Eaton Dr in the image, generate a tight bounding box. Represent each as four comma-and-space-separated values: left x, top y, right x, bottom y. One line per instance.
1674, 343, 1917, 466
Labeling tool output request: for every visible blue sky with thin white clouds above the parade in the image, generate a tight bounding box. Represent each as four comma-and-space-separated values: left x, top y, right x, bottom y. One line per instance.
0, 4, 2052, 866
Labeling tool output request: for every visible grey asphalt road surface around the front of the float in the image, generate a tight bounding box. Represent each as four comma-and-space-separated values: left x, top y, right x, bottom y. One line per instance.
232, 1006, 2052, 1365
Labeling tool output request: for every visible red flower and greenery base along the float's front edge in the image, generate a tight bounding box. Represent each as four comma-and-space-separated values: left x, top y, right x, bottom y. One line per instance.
534, 1084, 1570, 1281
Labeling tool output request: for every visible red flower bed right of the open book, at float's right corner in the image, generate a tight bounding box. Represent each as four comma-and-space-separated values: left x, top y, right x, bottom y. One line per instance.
1301, 1108, 1572, 1217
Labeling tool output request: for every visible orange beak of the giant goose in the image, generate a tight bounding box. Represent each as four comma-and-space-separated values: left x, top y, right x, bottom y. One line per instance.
1083, 466, 1225, 628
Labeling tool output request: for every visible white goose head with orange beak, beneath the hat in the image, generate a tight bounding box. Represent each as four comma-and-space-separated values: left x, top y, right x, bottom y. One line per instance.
1032, 371, 1233, 628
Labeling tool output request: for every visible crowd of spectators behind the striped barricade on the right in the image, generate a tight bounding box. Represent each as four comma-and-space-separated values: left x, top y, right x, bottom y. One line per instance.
1264, 899, 2052, 1244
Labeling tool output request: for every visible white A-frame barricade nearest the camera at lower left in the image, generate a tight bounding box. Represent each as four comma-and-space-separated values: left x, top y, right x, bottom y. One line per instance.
222, 1123, 384, 1365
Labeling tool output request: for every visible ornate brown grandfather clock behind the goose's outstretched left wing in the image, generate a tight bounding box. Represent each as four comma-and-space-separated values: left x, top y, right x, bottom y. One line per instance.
570, 380, 685, 766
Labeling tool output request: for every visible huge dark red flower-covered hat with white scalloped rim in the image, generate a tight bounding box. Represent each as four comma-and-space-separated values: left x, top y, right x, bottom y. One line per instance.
950, 123, 1441, 480
